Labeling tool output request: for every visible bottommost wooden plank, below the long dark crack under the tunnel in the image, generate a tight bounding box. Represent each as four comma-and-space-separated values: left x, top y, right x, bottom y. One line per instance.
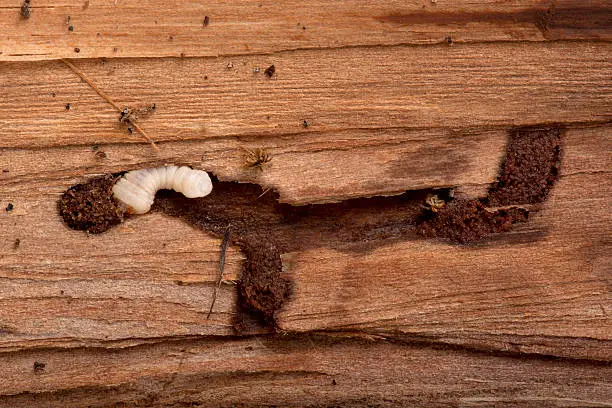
0, 336, 612, 408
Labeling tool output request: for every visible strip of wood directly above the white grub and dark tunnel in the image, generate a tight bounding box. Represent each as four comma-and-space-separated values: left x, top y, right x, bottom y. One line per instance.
0, 129, 508, 204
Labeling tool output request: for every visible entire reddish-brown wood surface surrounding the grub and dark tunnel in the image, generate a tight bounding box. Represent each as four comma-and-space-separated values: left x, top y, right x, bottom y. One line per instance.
0, 0, 612, 407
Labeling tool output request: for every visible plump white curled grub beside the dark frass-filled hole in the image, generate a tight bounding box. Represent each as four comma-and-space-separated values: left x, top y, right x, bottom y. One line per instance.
113, 166, 212, 214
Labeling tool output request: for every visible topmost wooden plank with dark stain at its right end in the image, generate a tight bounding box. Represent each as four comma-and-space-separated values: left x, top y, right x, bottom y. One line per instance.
0, 0, 612, 61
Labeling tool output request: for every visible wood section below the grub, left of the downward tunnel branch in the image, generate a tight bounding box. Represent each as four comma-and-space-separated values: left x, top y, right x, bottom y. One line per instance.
0, 206, 249, 350
